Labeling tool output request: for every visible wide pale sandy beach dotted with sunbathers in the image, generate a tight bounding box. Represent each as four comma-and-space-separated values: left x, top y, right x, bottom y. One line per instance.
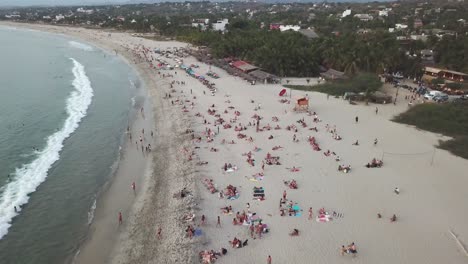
3, 24, 468, 263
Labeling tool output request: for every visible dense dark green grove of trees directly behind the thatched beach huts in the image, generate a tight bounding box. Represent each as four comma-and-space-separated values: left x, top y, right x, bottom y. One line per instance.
177, 27, 421, 77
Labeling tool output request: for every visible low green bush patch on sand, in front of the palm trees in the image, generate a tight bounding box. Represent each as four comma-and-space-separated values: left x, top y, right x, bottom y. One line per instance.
285, 74, 382, 96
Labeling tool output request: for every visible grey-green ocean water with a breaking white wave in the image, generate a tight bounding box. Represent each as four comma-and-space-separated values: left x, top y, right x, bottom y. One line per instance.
0, 26, 140, 264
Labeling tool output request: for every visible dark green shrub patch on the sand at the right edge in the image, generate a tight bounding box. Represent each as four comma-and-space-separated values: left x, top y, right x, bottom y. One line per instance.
394, 103, 468, 159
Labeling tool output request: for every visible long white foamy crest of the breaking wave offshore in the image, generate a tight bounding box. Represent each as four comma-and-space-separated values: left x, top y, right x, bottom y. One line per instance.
0, 58, 93, 239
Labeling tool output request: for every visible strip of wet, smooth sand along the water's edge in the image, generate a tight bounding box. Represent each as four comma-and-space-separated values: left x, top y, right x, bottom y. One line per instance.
1, 22, 186, 264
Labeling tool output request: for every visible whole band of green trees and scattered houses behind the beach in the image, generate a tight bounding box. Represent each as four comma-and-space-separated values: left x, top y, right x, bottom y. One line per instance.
0, 0, 468, 78
